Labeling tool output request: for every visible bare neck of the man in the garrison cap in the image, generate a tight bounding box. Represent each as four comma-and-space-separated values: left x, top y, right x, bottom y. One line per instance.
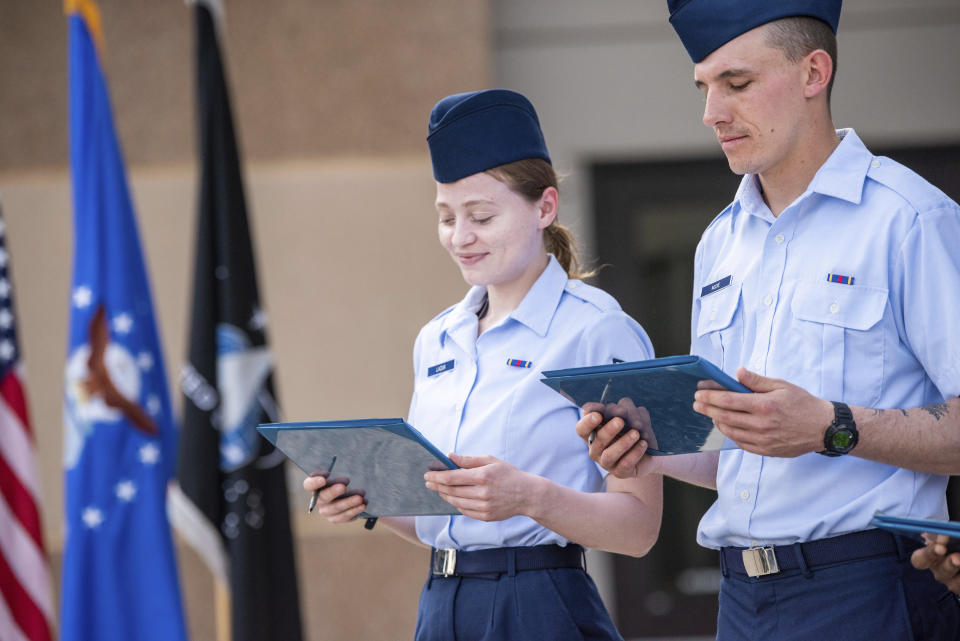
757, 119, 840, 216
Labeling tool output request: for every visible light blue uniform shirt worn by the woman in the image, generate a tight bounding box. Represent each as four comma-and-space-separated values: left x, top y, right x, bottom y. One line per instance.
409, 256, 653, 550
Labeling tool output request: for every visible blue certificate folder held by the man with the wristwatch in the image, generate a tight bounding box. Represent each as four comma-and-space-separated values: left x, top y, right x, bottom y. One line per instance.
542, 356, 750, 456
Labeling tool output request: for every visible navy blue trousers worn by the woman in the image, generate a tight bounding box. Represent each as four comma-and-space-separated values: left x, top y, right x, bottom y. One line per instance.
415, 568, 623, 641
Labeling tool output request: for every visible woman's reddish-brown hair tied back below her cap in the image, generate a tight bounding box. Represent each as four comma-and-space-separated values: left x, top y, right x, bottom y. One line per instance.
486, 158, 594, 279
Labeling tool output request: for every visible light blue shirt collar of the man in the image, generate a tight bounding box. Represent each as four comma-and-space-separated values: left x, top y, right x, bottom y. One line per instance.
734, 129, 873, 223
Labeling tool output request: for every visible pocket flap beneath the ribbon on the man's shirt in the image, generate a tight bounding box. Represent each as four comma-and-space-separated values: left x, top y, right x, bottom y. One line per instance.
791, 280, 887, 331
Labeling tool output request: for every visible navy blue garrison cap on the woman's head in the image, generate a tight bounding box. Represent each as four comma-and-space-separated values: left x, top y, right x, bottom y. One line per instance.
427, 89, 550, 183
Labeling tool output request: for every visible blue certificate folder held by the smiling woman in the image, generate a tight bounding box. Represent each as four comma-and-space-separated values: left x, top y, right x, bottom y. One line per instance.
257, 418, 460, 517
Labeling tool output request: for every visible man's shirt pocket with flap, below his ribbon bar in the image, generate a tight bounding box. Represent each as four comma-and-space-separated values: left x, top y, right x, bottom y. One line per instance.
792, 281, 888, 407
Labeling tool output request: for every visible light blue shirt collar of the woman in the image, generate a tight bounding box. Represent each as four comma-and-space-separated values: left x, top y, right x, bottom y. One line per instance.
440, 254, 567, 351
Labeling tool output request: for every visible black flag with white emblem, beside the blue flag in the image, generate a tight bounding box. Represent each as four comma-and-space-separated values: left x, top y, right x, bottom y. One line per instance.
173, 0, 302, 641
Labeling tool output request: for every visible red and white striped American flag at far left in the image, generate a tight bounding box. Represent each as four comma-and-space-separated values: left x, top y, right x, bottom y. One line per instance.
0, 208, 53, 641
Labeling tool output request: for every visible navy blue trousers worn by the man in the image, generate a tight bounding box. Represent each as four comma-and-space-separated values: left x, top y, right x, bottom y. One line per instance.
717, 554, 960, 641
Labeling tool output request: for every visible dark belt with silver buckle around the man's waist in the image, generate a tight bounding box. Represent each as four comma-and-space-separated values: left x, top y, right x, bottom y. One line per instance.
720, 530, 920, 577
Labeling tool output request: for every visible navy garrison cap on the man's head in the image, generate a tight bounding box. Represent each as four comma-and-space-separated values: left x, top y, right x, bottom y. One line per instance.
667, 0, 842, 63
